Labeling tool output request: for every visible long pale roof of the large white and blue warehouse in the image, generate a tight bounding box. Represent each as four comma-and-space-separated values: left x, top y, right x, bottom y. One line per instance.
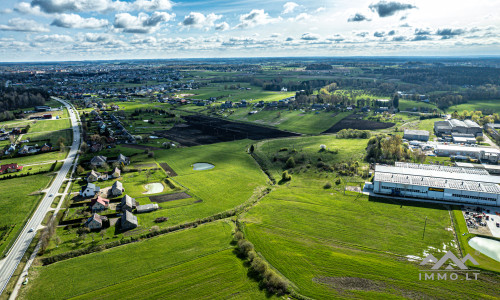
375, 172, 500, 194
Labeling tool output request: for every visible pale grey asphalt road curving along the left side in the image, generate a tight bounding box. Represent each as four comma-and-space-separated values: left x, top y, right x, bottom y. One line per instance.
0, 98, 80, 294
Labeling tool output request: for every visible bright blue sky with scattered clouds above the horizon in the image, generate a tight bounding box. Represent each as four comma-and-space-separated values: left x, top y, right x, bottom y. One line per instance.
0, 0, 500, 62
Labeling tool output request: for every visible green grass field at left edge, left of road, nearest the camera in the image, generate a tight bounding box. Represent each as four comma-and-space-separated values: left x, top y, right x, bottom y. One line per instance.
0, 174, 52, 254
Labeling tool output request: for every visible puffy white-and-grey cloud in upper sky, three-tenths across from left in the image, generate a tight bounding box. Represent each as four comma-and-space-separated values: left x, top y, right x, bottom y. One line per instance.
113, 12, 175, 33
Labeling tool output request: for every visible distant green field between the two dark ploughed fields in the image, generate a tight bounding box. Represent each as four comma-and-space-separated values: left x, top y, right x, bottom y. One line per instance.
229, 108, 350, 134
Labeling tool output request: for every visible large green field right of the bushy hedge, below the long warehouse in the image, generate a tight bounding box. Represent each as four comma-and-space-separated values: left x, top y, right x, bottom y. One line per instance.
242, 176, 500, 299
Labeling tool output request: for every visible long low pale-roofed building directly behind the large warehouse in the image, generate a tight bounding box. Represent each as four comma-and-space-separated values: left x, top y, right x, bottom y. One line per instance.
434, 145, 500, 163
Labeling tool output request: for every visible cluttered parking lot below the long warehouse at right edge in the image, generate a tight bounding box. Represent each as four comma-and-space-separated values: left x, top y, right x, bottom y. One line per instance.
462, 205, 500, 238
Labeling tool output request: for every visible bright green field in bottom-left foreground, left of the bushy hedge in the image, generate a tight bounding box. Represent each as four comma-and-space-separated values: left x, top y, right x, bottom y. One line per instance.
21, 221, 264, 299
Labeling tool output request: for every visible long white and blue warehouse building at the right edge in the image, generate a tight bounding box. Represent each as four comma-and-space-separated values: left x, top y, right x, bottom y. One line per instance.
373, 163, 500, 206
